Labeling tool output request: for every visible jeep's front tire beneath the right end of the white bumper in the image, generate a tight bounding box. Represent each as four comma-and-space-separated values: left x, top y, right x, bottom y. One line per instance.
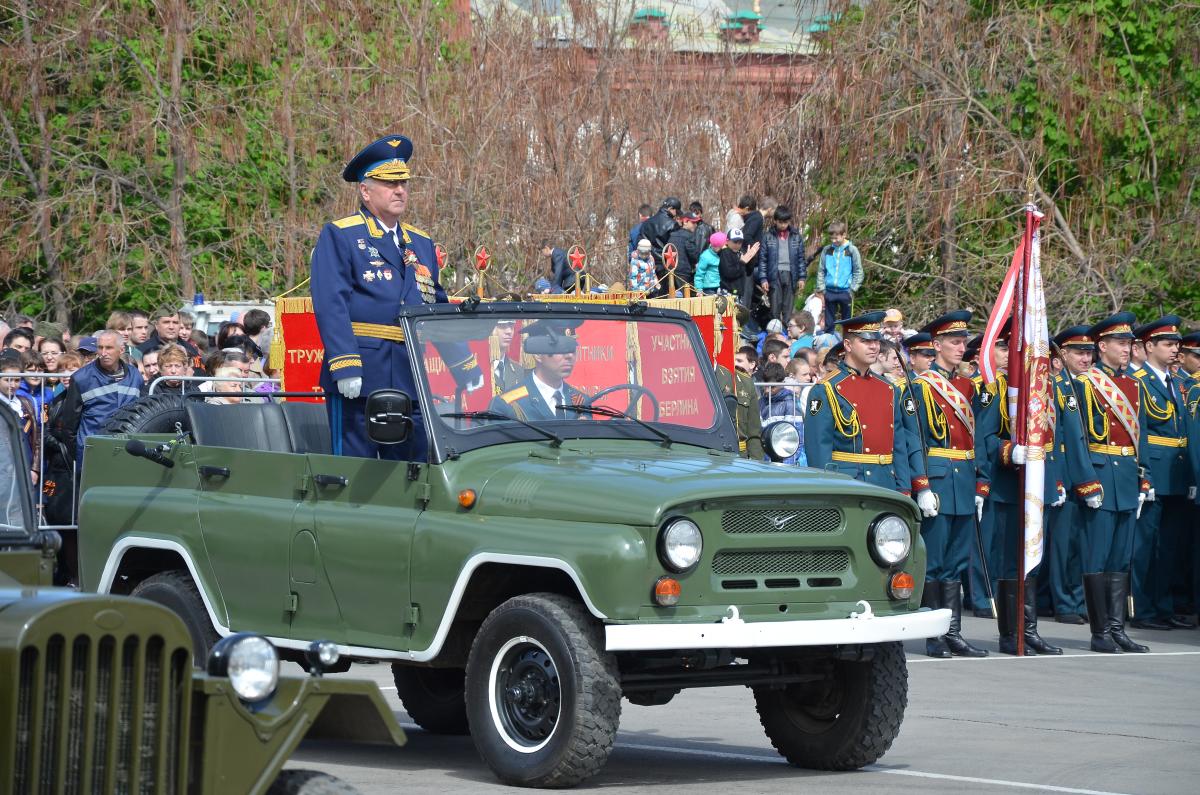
754, 642, 908, 770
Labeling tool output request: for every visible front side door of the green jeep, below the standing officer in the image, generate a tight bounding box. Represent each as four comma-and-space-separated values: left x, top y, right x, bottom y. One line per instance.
296, 454, 424, 650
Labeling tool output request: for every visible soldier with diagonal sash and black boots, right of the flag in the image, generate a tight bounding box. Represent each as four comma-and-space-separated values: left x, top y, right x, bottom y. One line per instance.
1076, 312, 1151, 653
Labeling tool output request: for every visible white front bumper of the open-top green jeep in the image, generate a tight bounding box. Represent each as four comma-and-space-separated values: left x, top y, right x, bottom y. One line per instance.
604, 602, 950, 651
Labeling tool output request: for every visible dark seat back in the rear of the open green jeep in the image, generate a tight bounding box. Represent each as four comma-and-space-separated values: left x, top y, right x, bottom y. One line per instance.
187, 400, 332, 455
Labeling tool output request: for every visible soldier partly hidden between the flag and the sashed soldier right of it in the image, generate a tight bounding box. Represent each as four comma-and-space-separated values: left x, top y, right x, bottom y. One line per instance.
1043, 325, 1098, 624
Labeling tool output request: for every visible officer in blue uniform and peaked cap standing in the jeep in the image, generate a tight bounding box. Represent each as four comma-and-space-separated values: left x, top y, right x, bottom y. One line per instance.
311, 136, 481, 461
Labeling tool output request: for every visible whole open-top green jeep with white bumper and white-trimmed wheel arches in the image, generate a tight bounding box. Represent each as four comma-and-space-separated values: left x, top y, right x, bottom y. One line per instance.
80, 303, 949, 785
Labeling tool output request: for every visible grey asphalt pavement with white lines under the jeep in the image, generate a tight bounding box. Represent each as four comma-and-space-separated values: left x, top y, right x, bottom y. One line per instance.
288, 617, 1200, 795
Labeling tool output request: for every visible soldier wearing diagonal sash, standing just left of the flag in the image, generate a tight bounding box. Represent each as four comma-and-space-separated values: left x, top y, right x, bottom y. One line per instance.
912, 310, 990, 657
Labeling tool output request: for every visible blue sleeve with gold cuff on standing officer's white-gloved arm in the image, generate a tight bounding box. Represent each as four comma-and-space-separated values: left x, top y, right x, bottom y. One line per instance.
311, 223, 362, 381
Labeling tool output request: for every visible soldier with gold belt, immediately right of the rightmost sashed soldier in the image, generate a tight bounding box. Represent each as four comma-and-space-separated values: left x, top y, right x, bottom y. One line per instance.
1132, 315, 1192, 629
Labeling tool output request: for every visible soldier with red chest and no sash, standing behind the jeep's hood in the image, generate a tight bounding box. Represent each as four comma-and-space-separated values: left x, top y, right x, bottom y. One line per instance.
804, 311, 937, 516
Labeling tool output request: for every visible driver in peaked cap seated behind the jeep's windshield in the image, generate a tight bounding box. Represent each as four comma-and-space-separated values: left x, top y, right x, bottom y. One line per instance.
491, 321, 587, 422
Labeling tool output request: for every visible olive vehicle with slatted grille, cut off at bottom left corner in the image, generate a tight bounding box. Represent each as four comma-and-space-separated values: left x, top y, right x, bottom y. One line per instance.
0, 384, 404, 795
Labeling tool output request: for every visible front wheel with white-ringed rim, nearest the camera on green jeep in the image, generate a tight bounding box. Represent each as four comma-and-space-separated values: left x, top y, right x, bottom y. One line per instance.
467, 593, 620, 787
